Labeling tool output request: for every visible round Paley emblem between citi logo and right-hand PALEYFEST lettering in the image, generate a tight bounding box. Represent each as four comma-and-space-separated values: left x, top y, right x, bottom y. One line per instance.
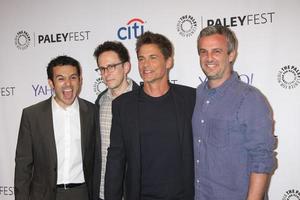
177, 15, 198, 37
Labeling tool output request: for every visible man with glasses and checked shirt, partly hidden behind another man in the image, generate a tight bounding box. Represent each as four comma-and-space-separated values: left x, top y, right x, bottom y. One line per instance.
94, 41, 139, 200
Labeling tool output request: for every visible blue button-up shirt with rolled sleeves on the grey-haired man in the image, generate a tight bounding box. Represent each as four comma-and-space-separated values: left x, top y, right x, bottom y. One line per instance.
193, 72, 275, 200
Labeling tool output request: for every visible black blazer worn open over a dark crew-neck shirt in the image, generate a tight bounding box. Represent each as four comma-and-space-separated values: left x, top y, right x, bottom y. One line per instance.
104, 84, 195, 200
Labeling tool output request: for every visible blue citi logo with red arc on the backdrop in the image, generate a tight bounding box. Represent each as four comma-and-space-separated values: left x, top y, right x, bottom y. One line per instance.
117, 18, 145, 40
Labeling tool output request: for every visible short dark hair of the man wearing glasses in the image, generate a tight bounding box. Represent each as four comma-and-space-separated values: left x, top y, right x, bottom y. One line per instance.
94, 41, 130, 65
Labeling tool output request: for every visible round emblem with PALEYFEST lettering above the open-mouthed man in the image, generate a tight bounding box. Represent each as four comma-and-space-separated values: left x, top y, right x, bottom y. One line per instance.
15, 30, 91, 50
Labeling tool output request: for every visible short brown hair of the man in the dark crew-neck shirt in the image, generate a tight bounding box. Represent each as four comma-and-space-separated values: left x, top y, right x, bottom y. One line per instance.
135, 31, 174, 59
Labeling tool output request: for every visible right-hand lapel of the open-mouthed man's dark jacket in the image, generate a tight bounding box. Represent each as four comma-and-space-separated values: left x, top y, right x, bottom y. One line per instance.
78, 97, 90, 161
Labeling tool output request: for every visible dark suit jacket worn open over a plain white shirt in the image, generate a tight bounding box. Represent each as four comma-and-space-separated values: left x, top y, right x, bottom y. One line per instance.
15, 98, 98, 200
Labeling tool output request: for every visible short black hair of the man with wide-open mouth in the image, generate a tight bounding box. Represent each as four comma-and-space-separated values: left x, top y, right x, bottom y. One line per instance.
47, 55, 81, 81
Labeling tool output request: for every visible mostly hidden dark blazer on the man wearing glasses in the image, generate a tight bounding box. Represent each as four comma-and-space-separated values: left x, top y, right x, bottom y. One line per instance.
94, 80, 139, 200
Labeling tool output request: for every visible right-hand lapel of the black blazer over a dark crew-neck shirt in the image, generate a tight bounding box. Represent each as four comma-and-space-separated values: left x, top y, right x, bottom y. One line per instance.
170, 84, 185, 144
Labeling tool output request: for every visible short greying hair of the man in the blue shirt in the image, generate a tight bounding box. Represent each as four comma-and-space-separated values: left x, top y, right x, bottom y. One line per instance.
197, 25, 238, 54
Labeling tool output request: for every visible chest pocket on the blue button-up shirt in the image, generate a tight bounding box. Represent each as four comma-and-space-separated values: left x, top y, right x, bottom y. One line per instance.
207, 118, 230, 148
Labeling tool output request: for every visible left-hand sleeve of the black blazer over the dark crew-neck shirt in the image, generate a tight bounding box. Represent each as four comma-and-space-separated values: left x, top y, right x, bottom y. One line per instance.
104, 101, 125, 200
